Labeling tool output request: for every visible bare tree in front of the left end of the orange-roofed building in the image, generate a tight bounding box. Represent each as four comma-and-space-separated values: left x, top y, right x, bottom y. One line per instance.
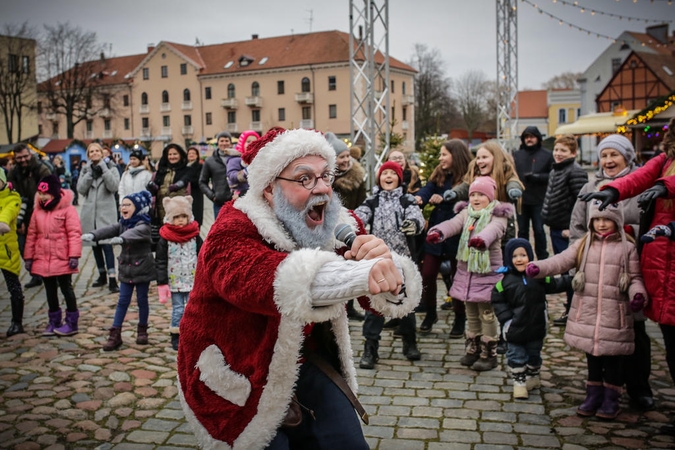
40, 23, 109, 138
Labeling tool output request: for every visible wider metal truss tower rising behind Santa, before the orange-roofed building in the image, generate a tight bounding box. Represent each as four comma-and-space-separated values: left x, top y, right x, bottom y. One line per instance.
349, 0, 391, 189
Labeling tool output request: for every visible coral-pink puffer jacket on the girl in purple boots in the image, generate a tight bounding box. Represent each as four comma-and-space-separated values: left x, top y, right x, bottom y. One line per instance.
23, 189, 82, 277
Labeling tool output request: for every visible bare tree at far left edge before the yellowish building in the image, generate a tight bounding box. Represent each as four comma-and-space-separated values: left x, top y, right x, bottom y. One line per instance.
0, 22, 37, 144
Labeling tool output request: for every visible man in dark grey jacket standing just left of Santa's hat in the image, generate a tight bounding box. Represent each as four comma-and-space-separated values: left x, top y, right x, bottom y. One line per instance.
199, 131, 234, 219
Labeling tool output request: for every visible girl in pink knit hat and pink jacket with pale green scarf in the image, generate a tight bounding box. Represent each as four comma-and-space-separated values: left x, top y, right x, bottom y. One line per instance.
427, 176, 515, 371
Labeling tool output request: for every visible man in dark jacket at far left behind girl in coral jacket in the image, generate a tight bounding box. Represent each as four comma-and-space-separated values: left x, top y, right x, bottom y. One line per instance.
7, 144, 52, 289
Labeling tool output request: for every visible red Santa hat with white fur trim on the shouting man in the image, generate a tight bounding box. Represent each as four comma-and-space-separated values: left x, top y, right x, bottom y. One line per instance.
241, 127, 335, 198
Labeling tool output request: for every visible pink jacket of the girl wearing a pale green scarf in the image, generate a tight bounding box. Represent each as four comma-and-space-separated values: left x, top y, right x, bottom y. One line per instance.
429, 202, 515, 303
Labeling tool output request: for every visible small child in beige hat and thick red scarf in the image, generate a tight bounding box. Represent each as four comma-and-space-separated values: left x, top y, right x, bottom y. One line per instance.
155, 195, 202, 350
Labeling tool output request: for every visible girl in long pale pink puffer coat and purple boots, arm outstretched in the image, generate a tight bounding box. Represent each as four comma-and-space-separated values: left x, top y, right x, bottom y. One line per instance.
526, 200, 648, 419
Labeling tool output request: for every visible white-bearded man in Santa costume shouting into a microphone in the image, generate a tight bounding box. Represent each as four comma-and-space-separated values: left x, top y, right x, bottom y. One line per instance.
177, 128, 421, 450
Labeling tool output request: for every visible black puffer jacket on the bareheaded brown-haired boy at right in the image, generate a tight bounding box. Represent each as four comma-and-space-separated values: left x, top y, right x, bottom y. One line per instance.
541, 158, 588, 230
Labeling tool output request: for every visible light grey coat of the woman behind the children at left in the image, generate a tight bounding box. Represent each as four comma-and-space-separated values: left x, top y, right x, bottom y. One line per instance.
77, 160, 120, 233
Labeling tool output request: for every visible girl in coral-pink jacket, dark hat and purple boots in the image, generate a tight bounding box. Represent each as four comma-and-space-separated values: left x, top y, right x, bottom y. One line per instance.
24, 175, 82, 336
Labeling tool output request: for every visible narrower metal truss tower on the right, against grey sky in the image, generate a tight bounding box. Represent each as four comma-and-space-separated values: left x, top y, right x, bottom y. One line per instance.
497, 0, 518, 150
